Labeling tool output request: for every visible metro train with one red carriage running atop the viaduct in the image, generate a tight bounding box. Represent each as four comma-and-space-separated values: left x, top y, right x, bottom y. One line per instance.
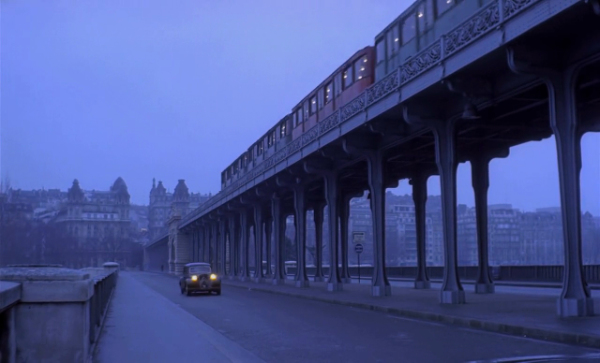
221, 0, 498, 191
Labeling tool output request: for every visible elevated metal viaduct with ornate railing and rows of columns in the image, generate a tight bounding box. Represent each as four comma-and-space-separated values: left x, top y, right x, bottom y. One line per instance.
145, 0, 600, 317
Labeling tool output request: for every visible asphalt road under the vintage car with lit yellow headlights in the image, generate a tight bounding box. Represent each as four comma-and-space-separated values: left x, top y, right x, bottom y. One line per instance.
128, 272, 594, 363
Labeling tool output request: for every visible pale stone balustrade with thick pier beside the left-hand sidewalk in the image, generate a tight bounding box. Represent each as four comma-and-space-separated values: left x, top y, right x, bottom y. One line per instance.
0, 263, 119, 363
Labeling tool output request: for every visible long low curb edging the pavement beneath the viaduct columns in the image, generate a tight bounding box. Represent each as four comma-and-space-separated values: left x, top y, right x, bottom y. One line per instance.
223, 281, 600, 349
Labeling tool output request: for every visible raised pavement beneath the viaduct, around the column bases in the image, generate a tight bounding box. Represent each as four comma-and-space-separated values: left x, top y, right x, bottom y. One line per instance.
223, 280, 600, 348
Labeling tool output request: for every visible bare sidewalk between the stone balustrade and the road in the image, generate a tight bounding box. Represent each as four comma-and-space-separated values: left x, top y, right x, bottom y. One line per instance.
94, 272, 262, 363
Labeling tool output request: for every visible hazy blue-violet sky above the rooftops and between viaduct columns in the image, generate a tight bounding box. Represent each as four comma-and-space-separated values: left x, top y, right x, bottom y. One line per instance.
1, 0, 600, 215
